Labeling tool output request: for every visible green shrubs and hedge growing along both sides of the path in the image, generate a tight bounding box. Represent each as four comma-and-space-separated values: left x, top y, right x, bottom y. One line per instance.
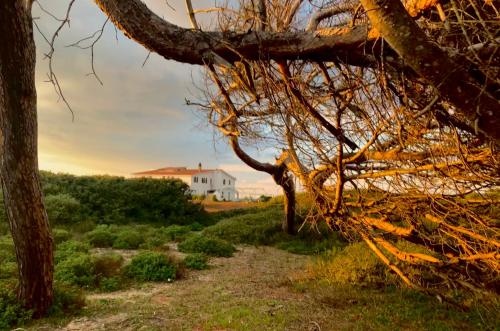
0, 173, 496, 330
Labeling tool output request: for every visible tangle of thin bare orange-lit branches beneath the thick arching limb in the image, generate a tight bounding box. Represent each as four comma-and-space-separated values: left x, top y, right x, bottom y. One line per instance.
190, 0, 500, 299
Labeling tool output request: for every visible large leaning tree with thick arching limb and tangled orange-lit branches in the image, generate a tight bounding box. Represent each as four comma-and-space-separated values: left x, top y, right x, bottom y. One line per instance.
92, 0, 500, 300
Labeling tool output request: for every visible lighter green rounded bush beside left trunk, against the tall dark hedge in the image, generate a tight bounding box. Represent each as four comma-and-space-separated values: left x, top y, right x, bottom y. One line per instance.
45, 193, 80, 225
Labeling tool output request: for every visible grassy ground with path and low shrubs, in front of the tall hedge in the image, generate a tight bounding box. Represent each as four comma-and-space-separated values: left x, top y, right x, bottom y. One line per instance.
0, 200, 500, 331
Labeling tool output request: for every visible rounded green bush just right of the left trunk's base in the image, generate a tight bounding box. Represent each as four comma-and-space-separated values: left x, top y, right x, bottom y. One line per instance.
54, 252, 97, 288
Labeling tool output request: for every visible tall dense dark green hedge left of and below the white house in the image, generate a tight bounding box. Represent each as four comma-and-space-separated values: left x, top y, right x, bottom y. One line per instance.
0, 171, 206, 226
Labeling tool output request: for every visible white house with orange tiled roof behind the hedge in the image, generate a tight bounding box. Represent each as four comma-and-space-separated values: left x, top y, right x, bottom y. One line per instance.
132, 163, 238, 201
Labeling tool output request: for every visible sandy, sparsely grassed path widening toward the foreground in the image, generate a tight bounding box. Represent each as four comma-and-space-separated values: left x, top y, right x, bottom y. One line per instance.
33, 246, 350, 331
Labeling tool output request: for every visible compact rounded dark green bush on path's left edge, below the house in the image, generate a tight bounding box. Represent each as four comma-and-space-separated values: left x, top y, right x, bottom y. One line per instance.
125, 252, 177, 281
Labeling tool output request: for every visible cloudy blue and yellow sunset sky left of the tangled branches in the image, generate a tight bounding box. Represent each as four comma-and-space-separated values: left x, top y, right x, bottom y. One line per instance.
33, 0, 279, 195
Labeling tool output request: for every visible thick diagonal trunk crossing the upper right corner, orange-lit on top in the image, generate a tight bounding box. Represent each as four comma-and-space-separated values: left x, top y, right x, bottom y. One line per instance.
360, 0, 500, 145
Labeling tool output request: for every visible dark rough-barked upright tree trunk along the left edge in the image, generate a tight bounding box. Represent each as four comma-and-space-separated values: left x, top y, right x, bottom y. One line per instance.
0, 0, 54, 317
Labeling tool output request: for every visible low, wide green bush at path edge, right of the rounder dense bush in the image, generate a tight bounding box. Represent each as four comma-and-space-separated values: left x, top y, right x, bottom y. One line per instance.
178, 235, 236, 257
